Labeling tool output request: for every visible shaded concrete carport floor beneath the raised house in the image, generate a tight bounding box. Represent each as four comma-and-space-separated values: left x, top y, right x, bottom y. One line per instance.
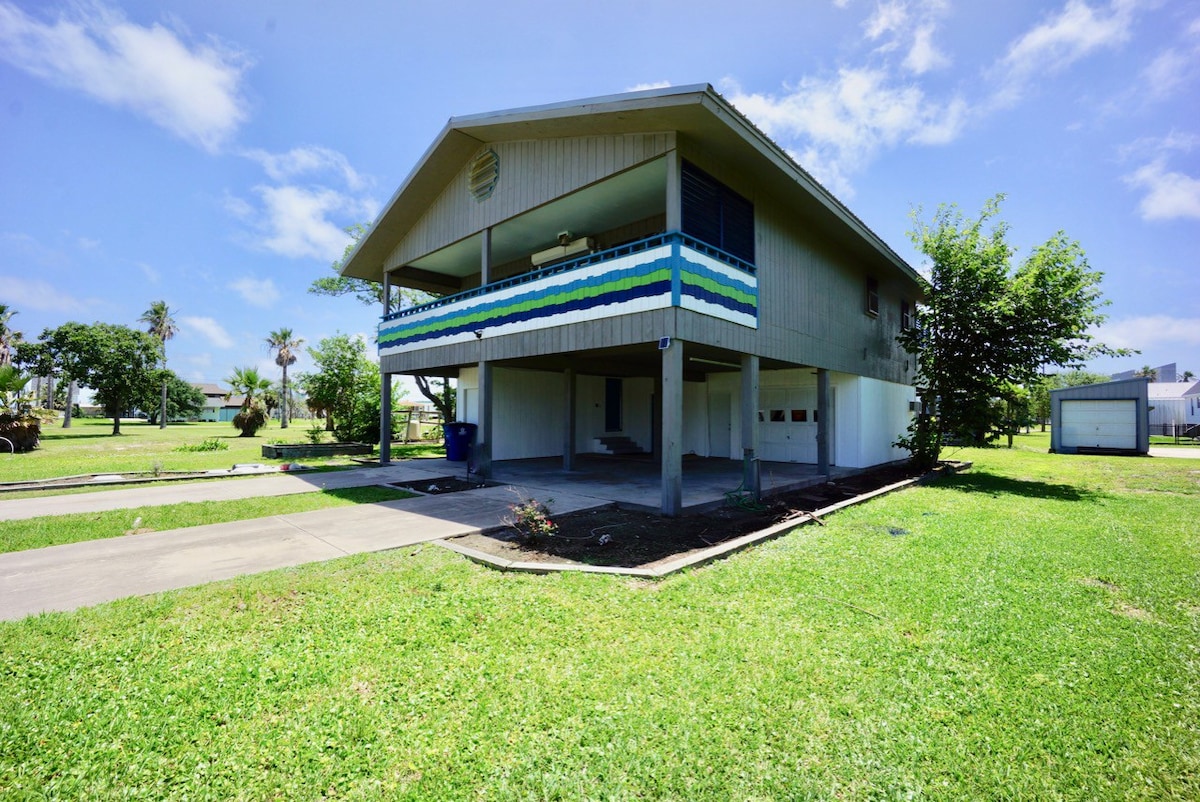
408, 454, 860, 515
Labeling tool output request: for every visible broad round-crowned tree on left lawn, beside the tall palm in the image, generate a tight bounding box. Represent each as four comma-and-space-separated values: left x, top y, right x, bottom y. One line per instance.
49, 323, 162, 435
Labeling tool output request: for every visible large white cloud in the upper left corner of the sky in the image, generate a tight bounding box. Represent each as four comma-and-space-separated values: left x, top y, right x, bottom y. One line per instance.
0, 2, 248, 151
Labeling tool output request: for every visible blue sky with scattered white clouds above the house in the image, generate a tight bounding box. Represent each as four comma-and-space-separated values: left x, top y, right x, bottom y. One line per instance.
0, 0, 1200, 393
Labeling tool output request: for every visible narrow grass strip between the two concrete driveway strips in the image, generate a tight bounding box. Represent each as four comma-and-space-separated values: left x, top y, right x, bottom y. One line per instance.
0, 485, 413, 553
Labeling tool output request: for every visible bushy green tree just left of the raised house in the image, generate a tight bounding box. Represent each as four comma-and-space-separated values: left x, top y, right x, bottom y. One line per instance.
299, 333, 398, 443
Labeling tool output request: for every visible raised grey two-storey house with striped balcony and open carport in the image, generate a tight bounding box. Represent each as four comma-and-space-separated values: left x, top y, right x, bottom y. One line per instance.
342, 85, 922, 514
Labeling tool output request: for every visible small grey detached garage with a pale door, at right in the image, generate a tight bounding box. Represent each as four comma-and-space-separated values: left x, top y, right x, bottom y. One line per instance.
1050, 378, 1150, 454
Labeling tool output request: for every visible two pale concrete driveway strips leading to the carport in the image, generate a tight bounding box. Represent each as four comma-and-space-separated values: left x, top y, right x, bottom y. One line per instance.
0, 463, 608, 621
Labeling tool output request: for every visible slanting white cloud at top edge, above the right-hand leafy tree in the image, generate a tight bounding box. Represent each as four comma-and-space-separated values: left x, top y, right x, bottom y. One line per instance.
995, 0, 1138, 106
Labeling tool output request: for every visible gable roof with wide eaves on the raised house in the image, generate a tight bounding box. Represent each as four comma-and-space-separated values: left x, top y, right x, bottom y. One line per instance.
341, 84, 924, 283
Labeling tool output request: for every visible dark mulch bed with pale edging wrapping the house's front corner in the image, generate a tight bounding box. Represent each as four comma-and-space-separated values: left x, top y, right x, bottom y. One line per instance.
454, 466, 916, 568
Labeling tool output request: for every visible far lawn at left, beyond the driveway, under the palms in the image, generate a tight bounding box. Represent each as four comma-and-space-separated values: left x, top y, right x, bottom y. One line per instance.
0, 418, 444, 481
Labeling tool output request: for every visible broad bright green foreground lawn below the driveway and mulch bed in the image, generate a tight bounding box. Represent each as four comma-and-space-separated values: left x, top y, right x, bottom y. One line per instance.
0, 441, 1200, 800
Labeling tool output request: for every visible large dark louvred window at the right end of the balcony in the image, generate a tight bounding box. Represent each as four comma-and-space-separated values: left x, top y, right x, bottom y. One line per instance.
680, 162, 754, 263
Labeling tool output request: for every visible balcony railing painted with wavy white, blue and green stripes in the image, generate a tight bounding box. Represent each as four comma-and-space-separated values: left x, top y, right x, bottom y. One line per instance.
379, 232, 758, 355
